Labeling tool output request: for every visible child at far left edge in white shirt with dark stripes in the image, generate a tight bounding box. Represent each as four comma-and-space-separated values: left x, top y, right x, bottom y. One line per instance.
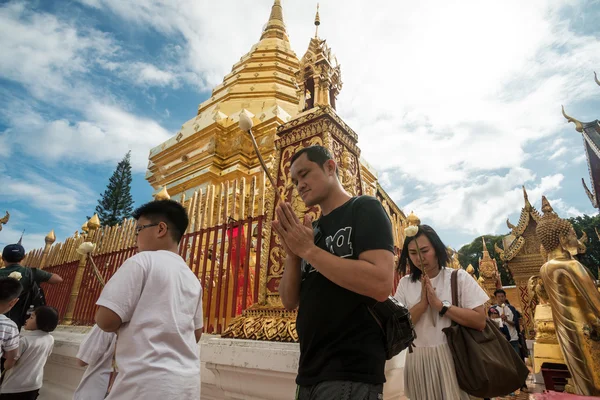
0, 278, 23, 372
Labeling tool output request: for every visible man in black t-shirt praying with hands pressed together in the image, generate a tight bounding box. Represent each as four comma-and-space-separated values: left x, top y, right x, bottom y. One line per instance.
273, 146, 394, 400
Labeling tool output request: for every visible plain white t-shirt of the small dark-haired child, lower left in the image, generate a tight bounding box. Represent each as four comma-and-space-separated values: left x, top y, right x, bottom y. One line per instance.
0, 329, 54, 393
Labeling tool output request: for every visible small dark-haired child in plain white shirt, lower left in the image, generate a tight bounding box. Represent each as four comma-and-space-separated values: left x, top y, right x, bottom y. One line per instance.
0, 306, 58, 400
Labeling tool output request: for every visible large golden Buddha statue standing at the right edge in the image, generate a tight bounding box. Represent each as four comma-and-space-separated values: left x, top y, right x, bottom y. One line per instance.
536, 197, 600, 396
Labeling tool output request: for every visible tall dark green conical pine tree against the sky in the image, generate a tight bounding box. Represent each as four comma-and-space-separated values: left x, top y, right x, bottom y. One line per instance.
96, 151, 133, 226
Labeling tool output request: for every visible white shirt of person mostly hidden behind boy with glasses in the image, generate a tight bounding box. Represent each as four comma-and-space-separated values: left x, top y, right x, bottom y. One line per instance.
73, 325, 117, 400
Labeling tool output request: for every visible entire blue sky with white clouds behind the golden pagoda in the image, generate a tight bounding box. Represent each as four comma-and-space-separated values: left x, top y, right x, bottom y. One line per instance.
0, 0, 600, 253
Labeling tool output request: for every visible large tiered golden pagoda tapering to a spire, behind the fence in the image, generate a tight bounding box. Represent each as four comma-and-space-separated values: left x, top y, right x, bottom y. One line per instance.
146, 0, 299, 198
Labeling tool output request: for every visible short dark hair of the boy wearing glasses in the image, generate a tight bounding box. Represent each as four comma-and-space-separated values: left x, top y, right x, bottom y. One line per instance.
132, 200, 189, 243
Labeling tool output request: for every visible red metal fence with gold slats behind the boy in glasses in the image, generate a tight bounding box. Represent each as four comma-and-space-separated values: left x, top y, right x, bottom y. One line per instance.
44, 216, 264, 333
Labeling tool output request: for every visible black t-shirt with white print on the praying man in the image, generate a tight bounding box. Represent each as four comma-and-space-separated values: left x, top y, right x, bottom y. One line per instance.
296, 196, 394, 386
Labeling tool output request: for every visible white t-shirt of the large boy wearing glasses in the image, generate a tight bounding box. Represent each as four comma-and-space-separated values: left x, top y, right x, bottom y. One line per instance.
96, 250, 203, 400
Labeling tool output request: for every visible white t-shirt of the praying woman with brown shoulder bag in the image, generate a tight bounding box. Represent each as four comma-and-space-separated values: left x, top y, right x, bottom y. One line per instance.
394, 268, 489, 347
